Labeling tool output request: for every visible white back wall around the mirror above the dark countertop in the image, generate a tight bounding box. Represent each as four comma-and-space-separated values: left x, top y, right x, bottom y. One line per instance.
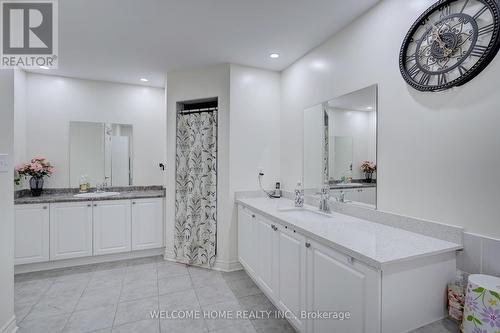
23, 73, 166, 187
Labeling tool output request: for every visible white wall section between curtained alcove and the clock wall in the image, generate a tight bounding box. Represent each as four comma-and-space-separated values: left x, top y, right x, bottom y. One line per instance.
230, 65, 280, 192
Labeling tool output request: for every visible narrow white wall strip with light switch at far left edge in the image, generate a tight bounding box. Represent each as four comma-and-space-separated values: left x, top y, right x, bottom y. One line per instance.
0, 69, 15, 332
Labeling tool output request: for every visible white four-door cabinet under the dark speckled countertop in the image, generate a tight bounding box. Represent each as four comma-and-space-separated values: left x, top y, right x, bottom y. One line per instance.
14, 198, 164, 271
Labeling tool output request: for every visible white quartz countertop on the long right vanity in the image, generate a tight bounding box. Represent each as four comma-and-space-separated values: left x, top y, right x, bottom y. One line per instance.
236, 198, 462, 269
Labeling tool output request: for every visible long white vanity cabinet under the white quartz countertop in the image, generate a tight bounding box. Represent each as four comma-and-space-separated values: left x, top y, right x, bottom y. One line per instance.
238, 204, 456, 333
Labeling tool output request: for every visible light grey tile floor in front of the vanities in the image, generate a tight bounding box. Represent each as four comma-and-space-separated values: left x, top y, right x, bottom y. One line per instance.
15, 256, 458, 333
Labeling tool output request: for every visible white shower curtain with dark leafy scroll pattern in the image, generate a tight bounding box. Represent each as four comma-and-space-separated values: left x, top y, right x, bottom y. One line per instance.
174, 110, 217, 267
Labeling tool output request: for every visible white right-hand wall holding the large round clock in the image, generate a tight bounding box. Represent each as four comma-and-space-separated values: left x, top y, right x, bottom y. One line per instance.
281, 0, 500, 238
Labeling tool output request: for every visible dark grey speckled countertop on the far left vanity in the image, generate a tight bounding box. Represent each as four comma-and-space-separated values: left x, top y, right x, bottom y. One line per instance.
14, 186, 165, 205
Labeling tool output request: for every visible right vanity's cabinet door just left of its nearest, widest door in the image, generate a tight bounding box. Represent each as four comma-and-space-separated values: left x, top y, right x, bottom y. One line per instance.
277, 225, 306, 332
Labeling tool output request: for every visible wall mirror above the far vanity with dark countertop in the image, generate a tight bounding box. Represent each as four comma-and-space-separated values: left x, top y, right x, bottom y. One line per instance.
69, 121, 133, 187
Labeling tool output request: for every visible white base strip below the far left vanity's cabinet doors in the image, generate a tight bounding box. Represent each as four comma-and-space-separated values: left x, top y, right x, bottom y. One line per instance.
14, 247, 165, 274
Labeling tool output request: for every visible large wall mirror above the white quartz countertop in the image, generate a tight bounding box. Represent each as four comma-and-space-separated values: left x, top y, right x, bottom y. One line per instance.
303, 85, 377, 208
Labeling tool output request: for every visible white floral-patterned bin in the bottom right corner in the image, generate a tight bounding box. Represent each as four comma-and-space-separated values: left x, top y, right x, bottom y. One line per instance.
462, 274, 500, 333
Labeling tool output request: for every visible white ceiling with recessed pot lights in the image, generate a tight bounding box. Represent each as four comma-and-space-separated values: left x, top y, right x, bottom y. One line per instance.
28, 0, 379, 87
